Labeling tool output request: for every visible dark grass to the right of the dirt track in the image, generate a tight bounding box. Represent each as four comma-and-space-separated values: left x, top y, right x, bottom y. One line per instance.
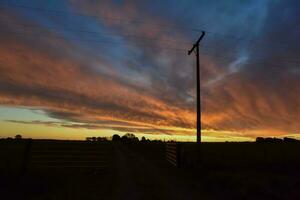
123, 142, 300, 199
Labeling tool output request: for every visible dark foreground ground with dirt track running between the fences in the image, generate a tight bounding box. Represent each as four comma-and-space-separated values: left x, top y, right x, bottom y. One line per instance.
0, 143, 300, 200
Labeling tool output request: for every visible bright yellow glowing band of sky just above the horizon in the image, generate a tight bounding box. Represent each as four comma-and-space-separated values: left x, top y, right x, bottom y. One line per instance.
0, 106, 300, 142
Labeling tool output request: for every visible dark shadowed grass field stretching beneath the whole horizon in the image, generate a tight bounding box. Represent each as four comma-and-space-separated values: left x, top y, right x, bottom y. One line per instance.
0, 140, 300, 199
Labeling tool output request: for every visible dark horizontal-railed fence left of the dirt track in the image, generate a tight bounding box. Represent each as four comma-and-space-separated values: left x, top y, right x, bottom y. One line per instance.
1, 140, 113, 173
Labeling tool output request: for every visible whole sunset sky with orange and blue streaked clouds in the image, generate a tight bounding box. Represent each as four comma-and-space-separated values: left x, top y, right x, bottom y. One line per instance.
0, 0, 300, 141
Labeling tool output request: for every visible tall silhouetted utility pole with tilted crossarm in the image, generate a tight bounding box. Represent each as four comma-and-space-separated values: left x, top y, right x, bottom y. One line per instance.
188, 31, 205, 144
